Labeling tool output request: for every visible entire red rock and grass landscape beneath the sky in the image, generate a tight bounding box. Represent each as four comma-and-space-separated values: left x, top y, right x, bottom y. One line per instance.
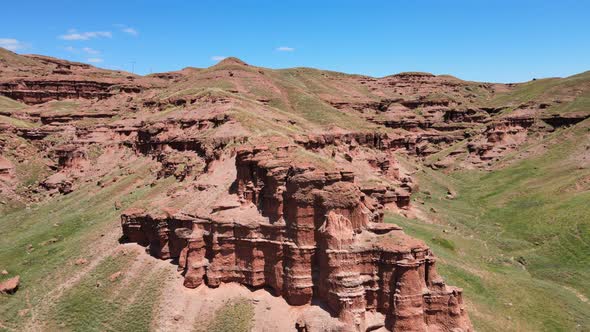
0, 49, 590, 331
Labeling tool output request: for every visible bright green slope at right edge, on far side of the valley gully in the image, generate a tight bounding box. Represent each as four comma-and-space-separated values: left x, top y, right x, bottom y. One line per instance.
445, 128, 590, 290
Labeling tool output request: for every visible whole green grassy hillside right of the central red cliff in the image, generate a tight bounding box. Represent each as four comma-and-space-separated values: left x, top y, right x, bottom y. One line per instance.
390, 120, 590, 331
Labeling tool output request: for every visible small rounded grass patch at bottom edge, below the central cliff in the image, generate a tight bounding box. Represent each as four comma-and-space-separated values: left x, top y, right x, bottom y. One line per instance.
207, 298, 254, 332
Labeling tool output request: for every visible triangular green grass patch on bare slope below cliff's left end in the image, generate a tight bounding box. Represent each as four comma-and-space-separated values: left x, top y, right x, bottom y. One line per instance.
47, 253, 164, 331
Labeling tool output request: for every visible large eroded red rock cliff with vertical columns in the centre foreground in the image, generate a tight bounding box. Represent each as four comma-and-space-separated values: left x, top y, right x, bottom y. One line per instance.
121, 146, 472, 331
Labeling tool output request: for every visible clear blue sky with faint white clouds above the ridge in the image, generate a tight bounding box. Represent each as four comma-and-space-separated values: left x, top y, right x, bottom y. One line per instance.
0, 0, 590, 82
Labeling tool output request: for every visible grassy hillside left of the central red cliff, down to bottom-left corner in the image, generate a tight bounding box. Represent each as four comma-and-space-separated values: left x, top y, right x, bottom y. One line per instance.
0, 160, 177, 331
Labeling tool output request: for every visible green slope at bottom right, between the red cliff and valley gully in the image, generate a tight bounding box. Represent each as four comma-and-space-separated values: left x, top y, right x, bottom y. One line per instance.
385, 213, 590, 331
